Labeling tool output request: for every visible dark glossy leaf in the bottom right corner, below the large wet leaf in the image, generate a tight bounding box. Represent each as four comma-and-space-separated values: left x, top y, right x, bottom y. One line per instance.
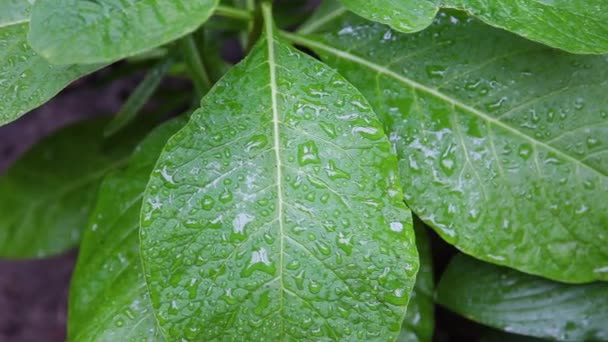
437, 254, 608, 341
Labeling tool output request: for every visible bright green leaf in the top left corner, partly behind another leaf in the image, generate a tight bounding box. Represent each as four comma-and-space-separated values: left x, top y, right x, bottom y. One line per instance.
0, 0, 99, 125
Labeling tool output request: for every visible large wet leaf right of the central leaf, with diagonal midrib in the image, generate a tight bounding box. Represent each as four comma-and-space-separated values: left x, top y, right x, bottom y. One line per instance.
286, 13, 608, 282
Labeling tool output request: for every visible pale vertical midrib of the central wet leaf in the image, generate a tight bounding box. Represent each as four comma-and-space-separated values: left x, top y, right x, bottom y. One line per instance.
265, 5, 285, 326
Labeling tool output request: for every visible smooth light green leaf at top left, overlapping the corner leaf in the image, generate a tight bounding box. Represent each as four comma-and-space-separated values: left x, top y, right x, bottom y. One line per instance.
29, 0, 218, 64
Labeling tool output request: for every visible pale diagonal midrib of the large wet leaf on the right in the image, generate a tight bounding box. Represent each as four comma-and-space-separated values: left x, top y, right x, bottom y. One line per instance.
282, 32, 608, 178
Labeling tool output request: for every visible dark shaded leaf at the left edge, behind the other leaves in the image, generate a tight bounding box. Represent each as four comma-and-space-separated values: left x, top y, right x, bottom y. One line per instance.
0, 120, 140, 258
